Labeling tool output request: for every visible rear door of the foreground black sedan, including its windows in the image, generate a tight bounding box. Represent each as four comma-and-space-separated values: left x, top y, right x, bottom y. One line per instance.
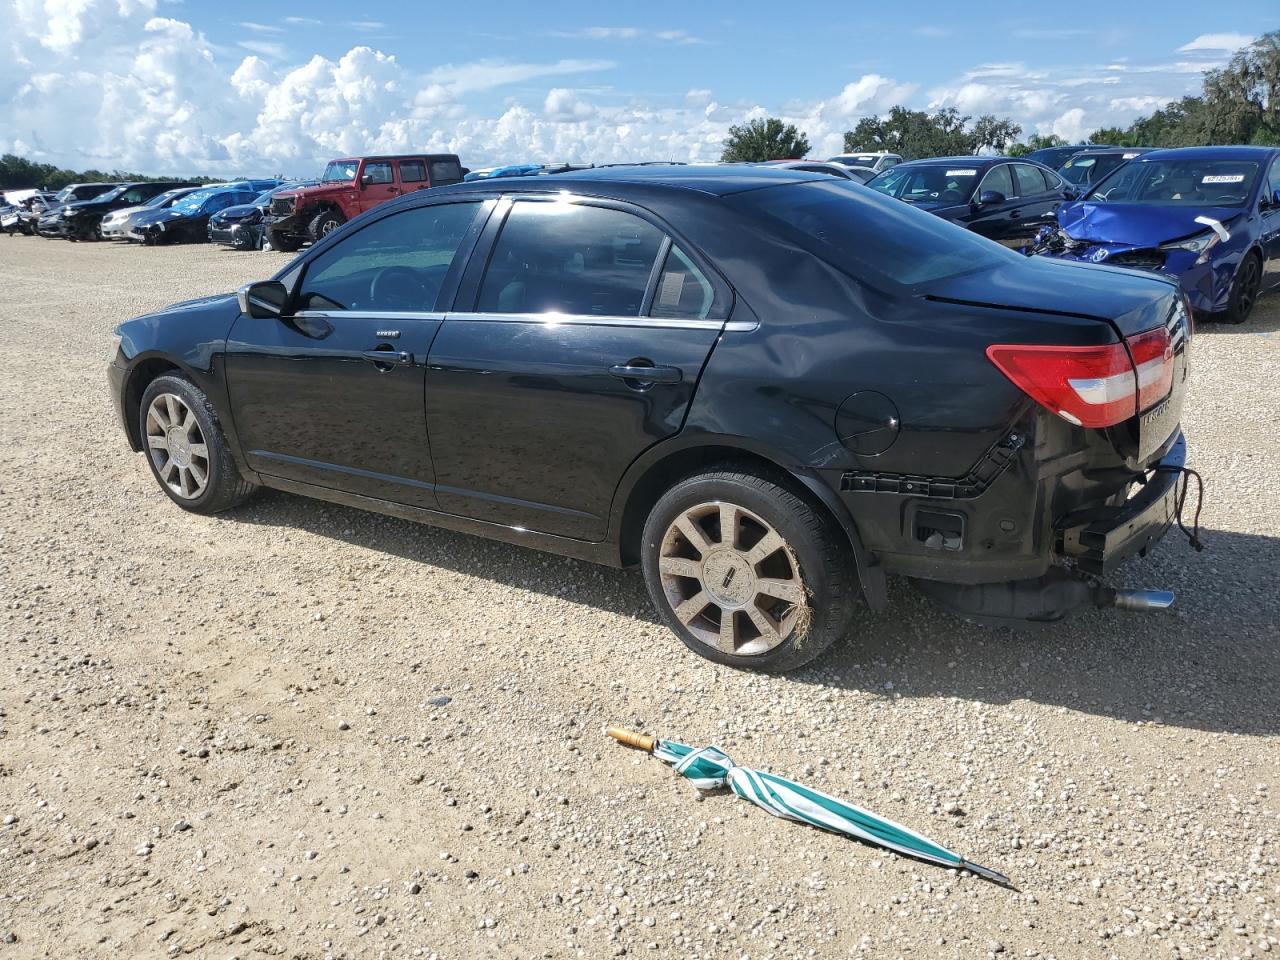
426, 197, 731, 540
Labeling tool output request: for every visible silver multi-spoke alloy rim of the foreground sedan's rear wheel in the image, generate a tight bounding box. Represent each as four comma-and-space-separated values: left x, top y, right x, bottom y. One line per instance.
658, 500, 809, 657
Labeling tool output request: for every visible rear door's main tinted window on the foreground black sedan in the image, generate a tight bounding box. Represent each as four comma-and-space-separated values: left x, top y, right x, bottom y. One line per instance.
477, 201, 662, 316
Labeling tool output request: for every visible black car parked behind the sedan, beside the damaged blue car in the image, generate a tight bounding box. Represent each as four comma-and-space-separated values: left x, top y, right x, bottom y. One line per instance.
867, 156, 1076, 247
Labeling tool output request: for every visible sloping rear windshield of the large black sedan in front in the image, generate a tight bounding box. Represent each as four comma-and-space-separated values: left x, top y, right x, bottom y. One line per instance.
727, 180, 1019, 287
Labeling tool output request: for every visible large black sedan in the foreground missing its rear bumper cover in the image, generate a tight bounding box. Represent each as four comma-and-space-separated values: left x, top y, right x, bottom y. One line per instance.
109, 166, 1189, 669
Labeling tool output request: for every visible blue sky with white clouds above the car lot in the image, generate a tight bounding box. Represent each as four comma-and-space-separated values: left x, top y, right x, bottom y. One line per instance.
0, 0, 1280, 177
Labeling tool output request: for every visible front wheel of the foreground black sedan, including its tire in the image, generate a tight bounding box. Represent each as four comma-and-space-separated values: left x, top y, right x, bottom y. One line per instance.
138, 374, 257, 513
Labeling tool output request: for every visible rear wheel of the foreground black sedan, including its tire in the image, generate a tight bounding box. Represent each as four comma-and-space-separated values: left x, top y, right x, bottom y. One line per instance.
640, 467, 859, 672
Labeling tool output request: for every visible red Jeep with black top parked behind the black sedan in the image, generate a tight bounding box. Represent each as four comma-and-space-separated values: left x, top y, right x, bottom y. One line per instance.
264, 154, 466, 252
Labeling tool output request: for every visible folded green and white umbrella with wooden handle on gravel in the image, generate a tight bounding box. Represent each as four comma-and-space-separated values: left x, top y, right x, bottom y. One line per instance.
605, 727, 1012, 887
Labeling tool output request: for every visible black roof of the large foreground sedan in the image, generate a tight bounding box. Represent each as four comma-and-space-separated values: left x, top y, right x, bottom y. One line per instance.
433, 164, 831, 196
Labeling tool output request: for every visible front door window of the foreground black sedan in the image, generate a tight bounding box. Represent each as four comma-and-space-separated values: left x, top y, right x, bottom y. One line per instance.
298, 202, 480, 311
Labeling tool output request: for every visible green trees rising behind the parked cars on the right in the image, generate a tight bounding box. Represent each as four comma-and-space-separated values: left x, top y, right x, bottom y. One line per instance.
721, 31, 1280, 163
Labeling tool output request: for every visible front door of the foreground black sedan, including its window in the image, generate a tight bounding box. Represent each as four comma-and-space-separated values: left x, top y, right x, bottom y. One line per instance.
227, 202, 483, 507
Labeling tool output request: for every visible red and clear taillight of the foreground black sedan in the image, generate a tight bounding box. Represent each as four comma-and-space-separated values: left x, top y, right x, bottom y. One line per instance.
987, 328, 1174, 428
